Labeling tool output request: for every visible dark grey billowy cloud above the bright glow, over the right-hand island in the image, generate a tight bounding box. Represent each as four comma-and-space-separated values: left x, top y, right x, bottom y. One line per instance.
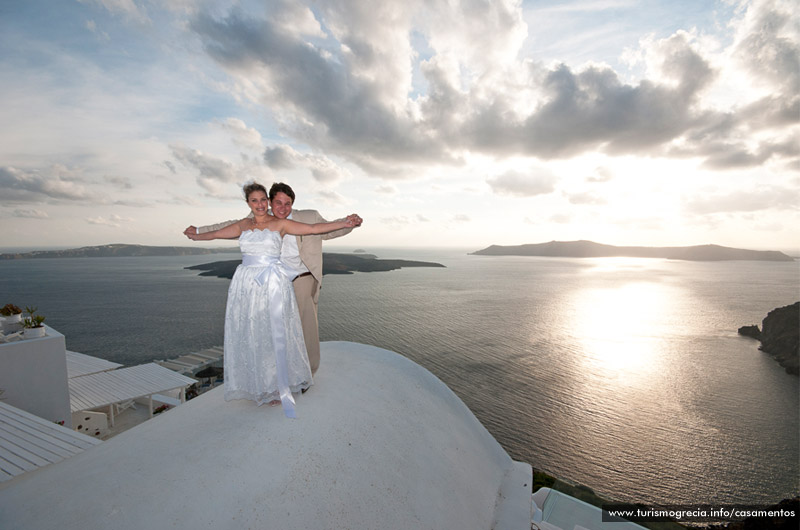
506, 35, 711, 158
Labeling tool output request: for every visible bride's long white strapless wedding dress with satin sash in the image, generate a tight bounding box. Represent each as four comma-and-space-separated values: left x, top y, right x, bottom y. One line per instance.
225, 230, 312, 418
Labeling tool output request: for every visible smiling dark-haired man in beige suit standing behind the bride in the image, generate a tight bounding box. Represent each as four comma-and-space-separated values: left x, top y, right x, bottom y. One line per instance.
183, 182, 361, 373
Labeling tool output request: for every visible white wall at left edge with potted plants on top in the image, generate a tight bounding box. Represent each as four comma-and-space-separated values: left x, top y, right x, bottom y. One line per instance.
0, 326, 72, 428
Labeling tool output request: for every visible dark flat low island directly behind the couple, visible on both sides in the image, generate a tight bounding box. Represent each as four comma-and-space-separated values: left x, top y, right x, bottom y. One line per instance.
184, 252, 444, 279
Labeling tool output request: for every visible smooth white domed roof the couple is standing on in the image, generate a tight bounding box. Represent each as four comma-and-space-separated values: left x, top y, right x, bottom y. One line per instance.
0, 342, 532, 530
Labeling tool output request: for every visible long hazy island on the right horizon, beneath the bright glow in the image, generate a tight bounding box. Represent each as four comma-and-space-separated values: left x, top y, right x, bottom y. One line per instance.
470, 241, 794, 261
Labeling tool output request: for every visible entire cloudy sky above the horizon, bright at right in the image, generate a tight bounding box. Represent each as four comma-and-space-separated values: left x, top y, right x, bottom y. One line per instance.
0, 0, 800, 254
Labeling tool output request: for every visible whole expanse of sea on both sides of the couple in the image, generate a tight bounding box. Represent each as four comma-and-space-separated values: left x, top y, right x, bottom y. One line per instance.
0, 247, 800, 505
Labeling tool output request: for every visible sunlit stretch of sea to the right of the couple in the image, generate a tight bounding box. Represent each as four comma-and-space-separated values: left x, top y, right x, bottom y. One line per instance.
320, 253, 799, 502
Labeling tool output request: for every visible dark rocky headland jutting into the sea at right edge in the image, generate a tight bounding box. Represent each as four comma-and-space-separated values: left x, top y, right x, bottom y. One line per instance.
739, 302, 800, 375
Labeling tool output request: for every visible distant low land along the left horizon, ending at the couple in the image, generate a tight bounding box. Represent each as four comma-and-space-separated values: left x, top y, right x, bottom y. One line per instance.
0, 243, 239, 259
